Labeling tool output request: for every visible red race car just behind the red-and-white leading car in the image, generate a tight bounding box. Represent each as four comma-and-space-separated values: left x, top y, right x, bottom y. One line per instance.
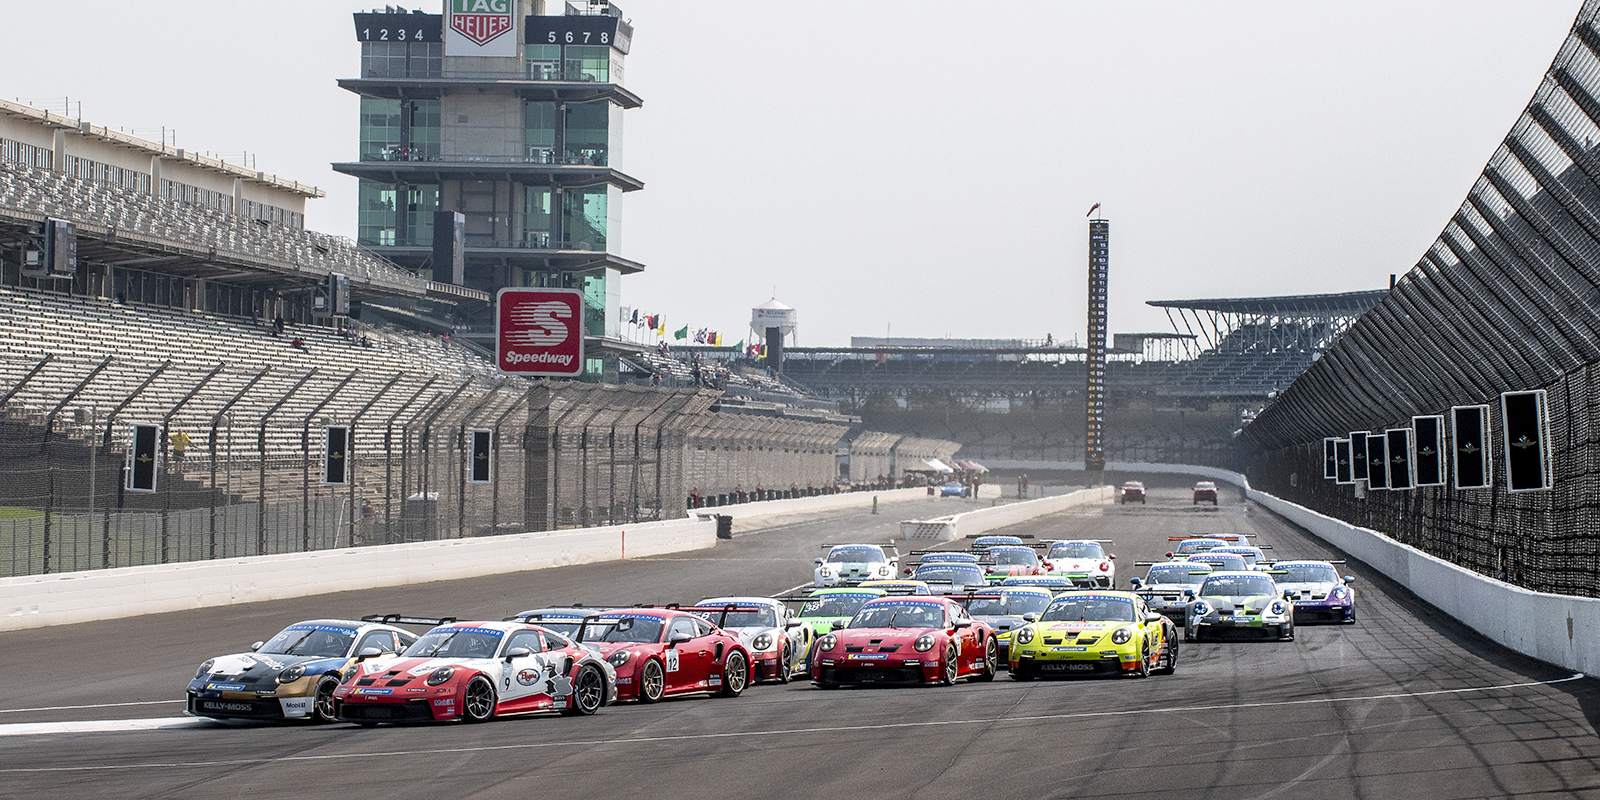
582, 608, 750, 702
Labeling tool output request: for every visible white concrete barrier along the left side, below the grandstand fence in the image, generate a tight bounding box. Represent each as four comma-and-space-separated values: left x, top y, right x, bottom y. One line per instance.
0, 518, 717, 630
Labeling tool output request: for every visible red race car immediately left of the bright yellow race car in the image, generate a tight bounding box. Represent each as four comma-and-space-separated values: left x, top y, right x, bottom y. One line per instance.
811, 597, 1000, 690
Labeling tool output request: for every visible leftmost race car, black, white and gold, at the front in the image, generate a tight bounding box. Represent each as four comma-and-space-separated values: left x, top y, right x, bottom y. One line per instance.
184, 619, 416, 722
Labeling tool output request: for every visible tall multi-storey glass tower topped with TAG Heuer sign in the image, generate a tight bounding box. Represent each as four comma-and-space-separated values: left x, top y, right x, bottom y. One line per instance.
333, 0, 643, 378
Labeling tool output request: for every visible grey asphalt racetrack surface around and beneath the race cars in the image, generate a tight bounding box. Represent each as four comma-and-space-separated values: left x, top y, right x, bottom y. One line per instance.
0, 477, 1600, 800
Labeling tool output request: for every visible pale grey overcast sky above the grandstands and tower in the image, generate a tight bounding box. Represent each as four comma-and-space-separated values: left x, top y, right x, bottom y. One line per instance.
0, 0, 1581, 344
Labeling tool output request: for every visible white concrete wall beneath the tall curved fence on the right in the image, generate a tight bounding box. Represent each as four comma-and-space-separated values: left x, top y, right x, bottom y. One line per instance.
998, 461, 1600, 675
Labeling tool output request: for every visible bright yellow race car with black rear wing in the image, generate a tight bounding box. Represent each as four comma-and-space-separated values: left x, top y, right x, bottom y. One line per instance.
1010, 589, 1179, 680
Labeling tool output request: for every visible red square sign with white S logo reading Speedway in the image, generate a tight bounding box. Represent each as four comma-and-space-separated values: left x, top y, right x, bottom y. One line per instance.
494, 288, 584, 378
